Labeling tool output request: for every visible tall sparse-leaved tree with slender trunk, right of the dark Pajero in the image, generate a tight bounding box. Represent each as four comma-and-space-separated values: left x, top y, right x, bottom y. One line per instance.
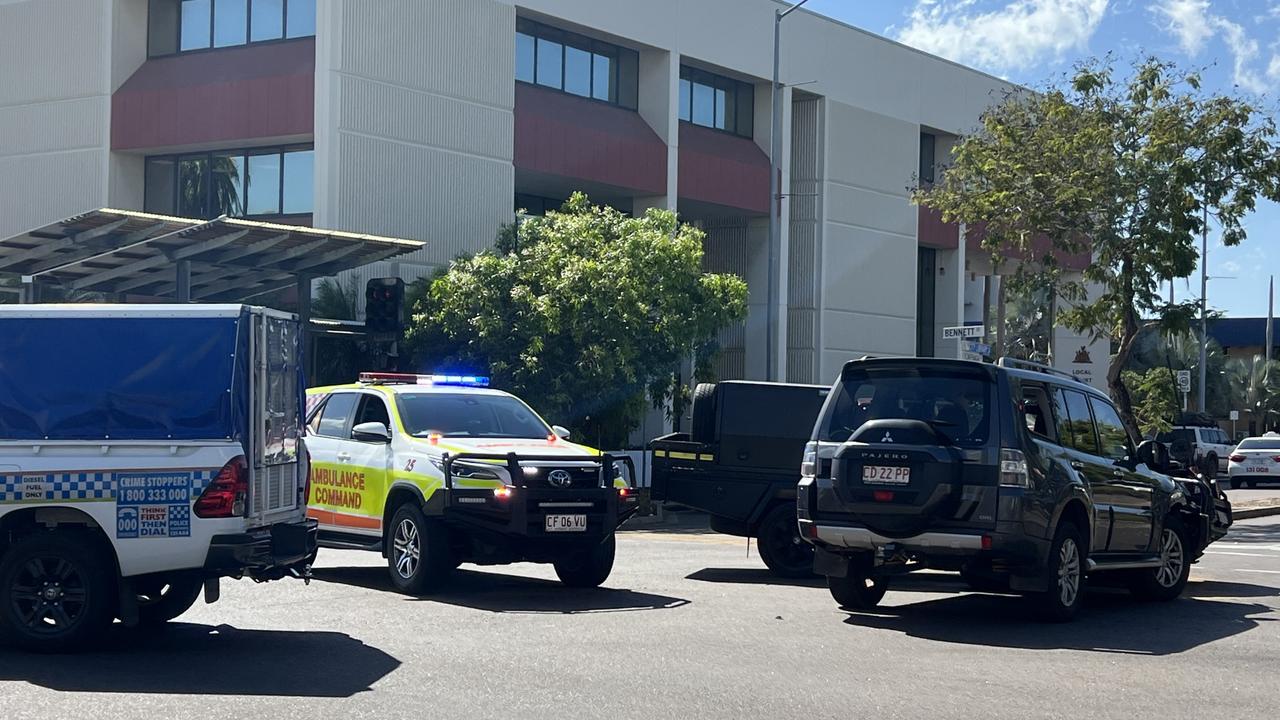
916, 59, 1280, 429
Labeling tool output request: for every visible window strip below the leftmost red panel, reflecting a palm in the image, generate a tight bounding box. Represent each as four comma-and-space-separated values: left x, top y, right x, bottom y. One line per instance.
143, 146, 315, 219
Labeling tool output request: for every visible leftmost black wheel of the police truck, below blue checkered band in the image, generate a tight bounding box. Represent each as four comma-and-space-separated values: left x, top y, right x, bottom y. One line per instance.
0, 530, 116, 652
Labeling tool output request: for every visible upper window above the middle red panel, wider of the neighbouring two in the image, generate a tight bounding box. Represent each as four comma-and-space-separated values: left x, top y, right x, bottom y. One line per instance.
516, 18, 640, 110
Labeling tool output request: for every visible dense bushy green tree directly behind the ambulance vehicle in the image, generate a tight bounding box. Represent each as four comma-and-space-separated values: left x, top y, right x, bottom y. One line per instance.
406, 193, 746, 447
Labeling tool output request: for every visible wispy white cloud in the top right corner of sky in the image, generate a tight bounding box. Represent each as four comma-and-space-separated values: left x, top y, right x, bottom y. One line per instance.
1151, 0, 1280, 94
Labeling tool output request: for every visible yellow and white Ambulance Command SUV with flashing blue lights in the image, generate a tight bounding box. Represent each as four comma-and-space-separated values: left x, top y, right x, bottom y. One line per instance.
307, 373, 636, 594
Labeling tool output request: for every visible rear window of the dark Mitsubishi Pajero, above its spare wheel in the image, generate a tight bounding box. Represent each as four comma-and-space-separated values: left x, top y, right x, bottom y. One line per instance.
818, 366, 993, 447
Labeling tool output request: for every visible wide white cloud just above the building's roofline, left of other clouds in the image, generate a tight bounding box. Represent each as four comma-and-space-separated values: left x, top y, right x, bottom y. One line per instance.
897, 0, 1108, 72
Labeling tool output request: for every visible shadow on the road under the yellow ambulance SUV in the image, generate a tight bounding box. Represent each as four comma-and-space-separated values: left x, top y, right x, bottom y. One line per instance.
311, 566, 689, 615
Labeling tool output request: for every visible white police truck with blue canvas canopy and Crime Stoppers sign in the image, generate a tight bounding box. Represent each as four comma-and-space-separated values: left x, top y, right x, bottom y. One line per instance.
0, 305, 316, 651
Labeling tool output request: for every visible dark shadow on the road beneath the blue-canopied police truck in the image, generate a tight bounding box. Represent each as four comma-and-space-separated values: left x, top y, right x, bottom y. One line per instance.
0, 623, 401, 697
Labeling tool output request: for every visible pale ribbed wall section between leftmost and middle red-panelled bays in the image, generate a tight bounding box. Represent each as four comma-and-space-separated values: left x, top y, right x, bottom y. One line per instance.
314, 0, 516, 283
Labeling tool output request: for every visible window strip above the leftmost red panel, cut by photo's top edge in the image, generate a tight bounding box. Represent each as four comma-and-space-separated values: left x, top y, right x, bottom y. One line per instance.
147, 0, 316, 58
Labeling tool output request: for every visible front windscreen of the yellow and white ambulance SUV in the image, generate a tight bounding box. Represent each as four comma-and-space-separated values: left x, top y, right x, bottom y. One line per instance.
396, 392, 552, 438
